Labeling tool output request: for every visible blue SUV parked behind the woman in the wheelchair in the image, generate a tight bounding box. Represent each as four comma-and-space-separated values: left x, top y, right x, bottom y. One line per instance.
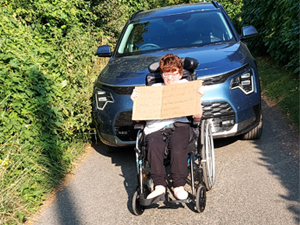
93, 1, 262, 150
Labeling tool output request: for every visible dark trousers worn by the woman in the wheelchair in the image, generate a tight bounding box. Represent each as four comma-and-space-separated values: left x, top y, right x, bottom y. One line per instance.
146, 124, 190, 187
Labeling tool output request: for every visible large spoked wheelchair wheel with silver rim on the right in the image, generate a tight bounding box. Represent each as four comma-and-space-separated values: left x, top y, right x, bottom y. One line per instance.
201, 120, 215, 191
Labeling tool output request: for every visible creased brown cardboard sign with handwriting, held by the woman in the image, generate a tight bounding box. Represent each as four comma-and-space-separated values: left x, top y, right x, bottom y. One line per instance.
132, 80, 202, 120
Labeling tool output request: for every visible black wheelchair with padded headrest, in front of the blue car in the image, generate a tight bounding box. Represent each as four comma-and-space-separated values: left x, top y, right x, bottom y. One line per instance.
132, 58, 215, 215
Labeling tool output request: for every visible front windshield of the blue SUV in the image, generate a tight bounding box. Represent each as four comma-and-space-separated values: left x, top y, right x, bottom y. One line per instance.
117, 10, 234, 55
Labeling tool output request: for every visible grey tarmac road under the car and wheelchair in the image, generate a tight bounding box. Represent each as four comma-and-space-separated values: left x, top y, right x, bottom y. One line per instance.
30, 102, 300, 225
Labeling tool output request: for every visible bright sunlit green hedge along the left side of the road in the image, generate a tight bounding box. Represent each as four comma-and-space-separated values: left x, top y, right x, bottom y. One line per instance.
0, 0, 100, 224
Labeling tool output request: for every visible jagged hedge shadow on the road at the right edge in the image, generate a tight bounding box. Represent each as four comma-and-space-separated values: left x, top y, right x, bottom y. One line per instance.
254, 101, 300, 224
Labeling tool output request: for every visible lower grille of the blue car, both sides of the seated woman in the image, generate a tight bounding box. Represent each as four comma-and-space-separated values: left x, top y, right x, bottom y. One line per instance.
115, 101, 235, 141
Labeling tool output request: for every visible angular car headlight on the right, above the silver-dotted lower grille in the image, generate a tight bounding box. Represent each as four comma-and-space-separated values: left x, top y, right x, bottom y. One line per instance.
230, 69, 254, 95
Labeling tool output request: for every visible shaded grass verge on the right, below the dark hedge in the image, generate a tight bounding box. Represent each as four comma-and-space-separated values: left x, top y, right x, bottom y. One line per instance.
256, 56, 299, 133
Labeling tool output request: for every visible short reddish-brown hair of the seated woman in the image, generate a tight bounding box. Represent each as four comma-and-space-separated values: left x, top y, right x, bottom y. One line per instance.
159, 54, 183, 75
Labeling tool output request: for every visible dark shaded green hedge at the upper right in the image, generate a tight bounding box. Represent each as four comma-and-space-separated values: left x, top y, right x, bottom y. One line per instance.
242, 0, 300, 73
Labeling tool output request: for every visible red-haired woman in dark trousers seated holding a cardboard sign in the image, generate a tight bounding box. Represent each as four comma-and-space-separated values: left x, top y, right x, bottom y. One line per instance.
131, 54, 205, 200
